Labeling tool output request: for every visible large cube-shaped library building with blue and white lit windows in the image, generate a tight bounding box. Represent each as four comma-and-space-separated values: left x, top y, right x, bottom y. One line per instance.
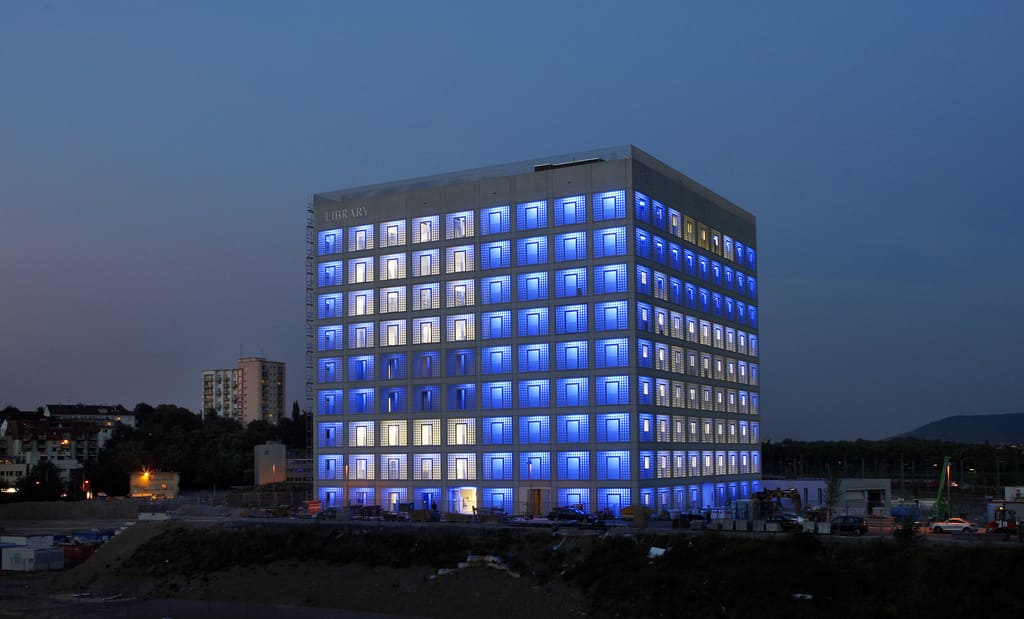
307, 147, 761, 514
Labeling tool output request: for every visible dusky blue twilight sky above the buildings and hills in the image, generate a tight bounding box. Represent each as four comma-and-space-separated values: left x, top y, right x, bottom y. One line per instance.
0, 1, 1024, 441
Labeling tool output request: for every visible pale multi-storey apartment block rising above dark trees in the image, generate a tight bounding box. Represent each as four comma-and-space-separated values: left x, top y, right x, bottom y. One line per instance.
202, 357, 285, 425
